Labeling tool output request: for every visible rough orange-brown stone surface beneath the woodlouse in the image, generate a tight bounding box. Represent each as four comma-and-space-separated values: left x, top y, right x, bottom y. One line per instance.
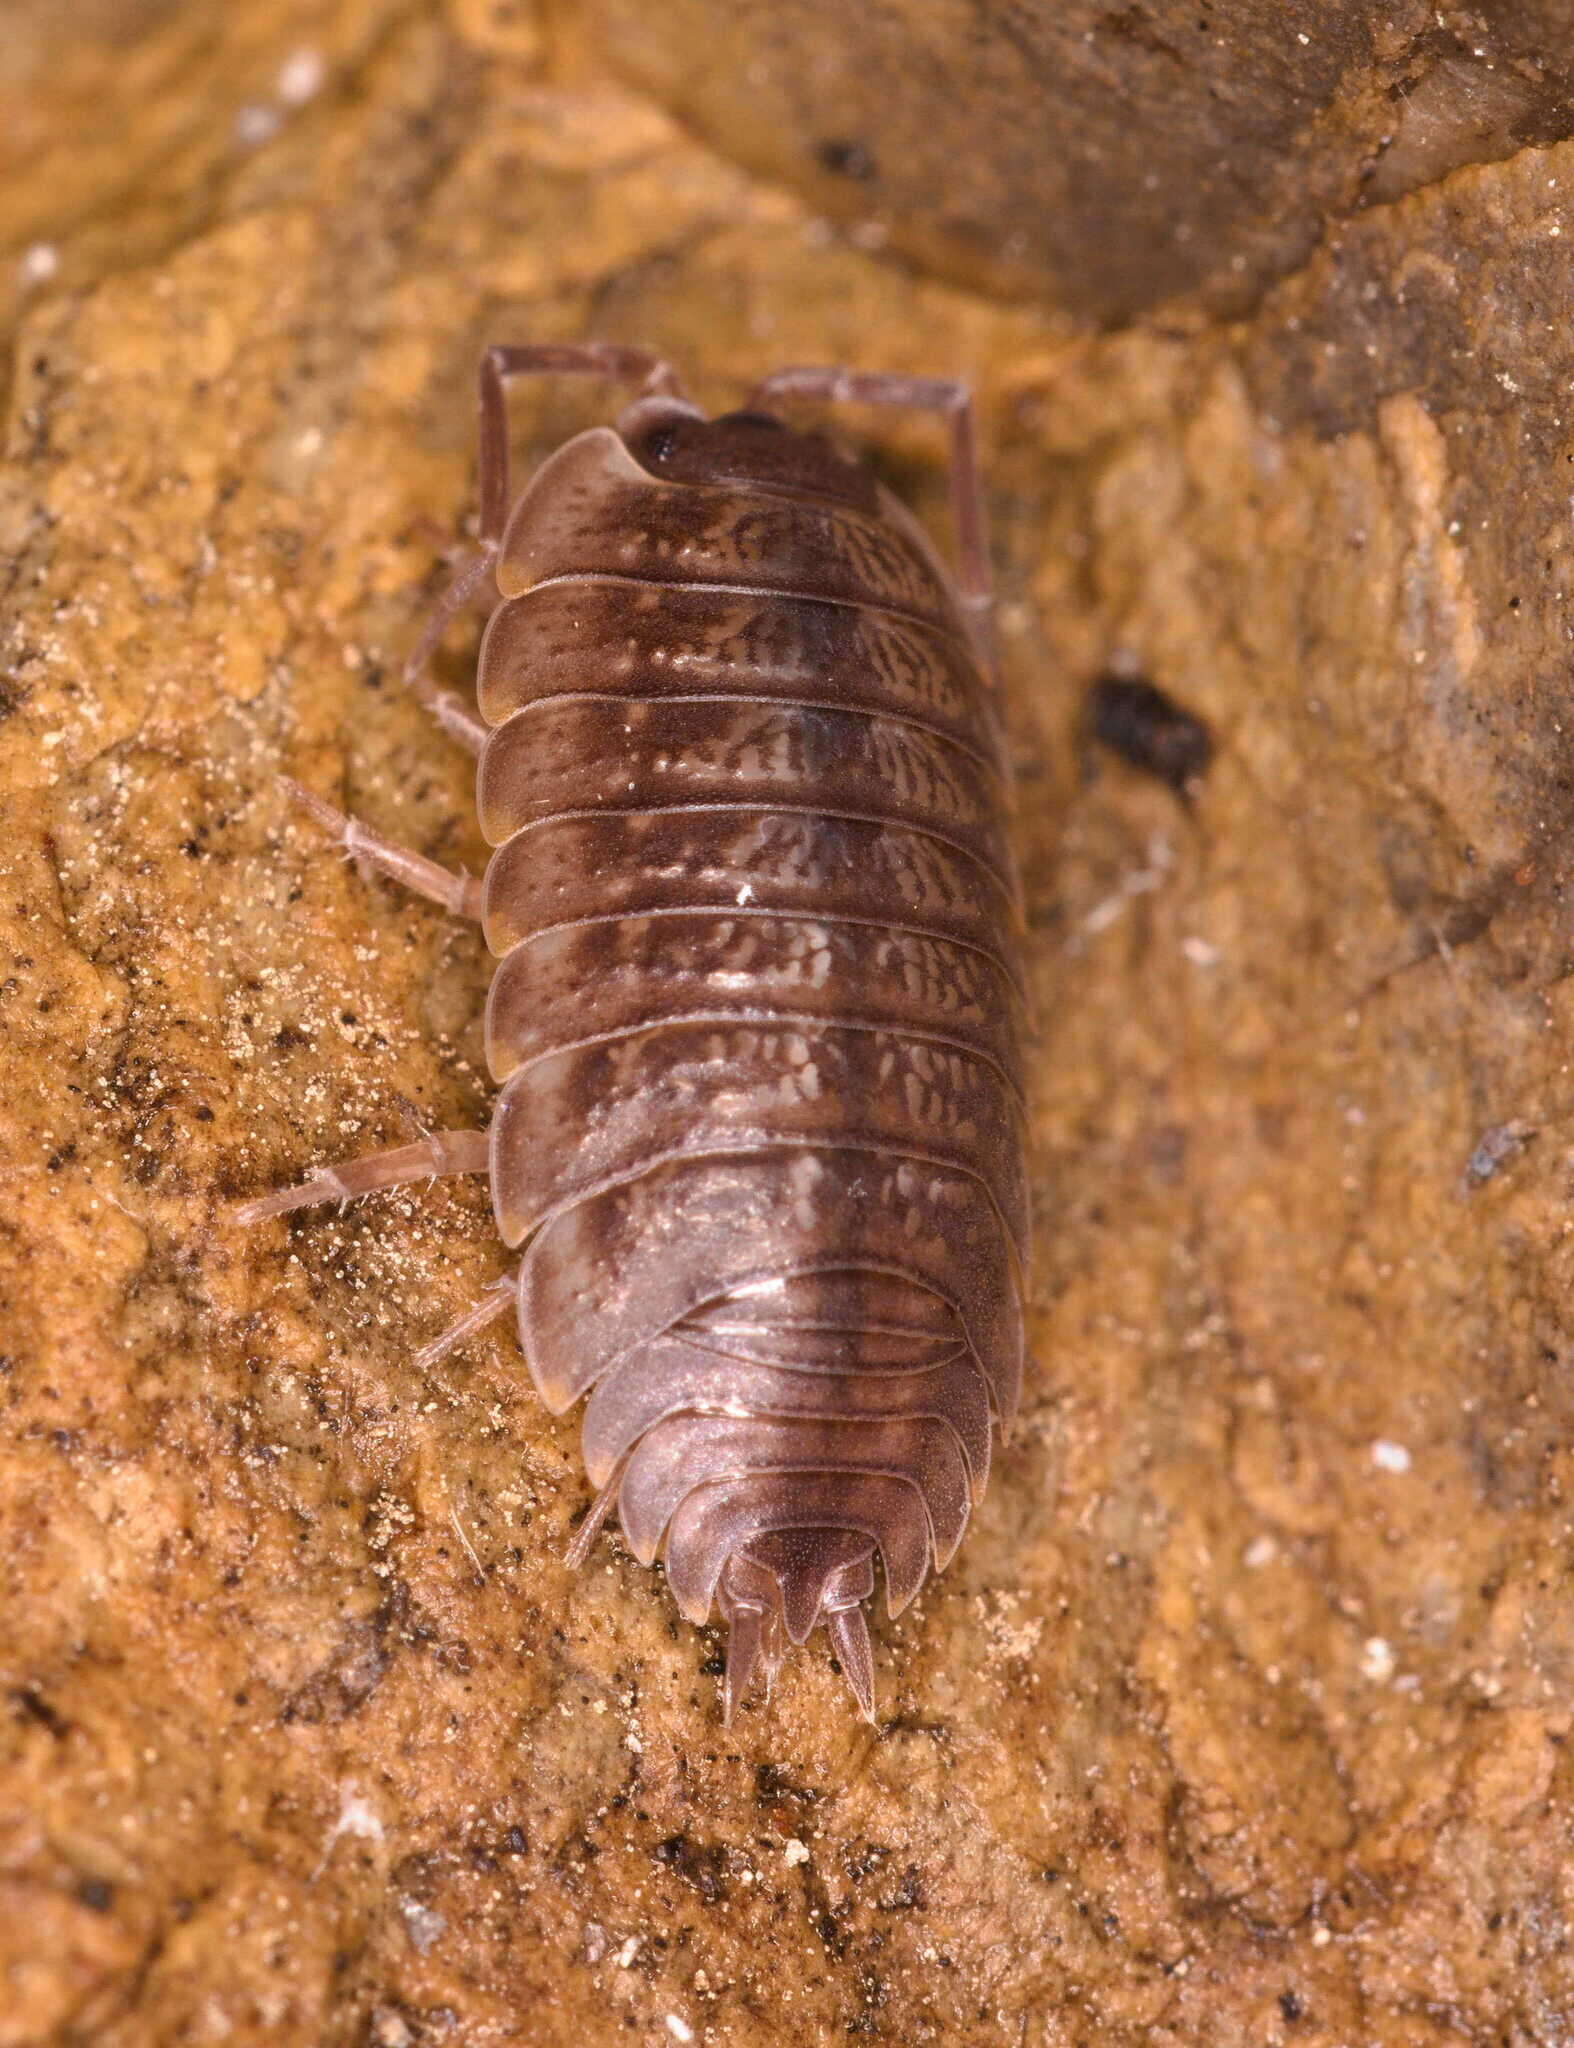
0, 0, 1574, 2048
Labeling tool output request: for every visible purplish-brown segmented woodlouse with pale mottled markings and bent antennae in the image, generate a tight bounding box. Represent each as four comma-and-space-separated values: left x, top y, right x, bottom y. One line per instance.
239, 344, 1028, 1718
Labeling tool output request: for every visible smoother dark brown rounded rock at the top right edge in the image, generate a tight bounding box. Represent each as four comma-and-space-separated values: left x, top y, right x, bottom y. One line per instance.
592, 0, 1574, 322
